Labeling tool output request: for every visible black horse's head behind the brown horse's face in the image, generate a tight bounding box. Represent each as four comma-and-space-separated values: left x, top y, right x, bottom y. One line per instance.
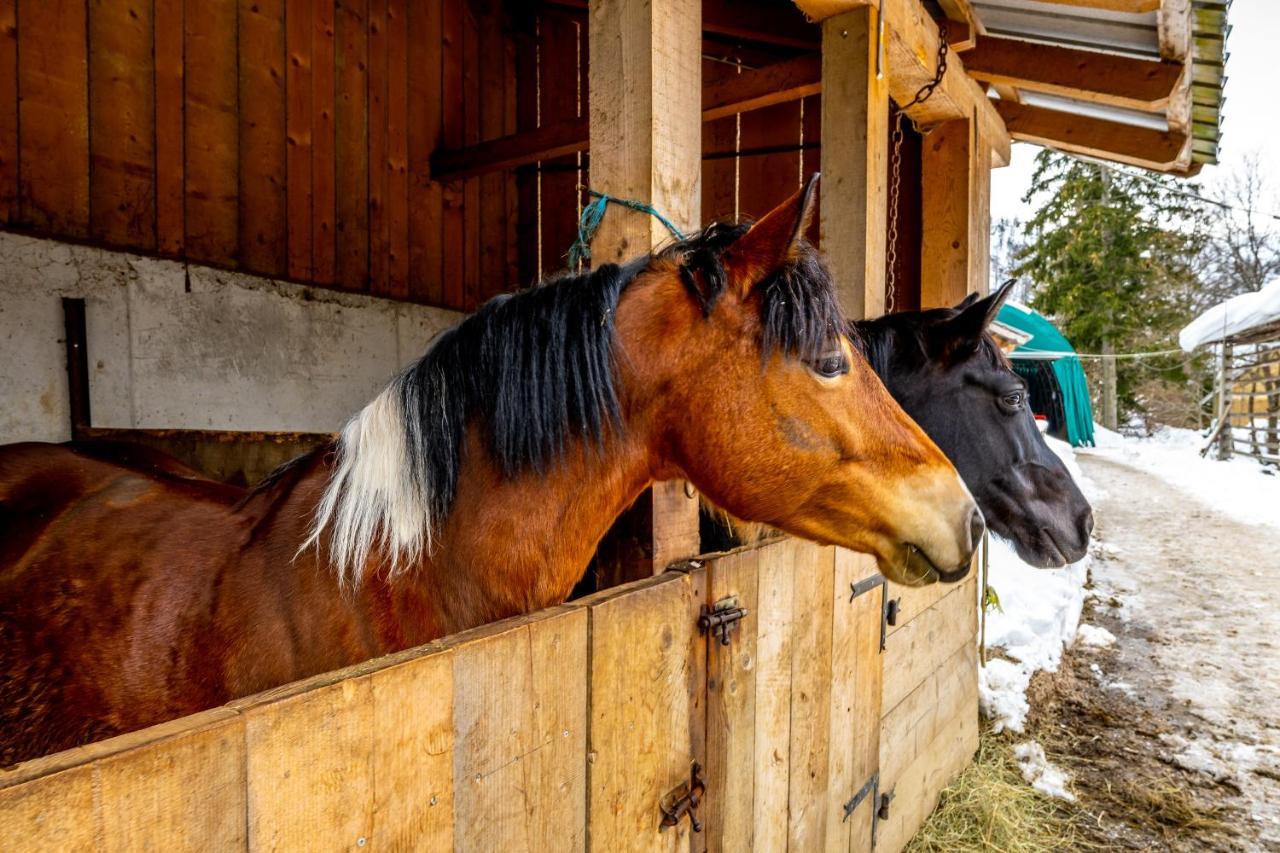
851, 282, 1093, 567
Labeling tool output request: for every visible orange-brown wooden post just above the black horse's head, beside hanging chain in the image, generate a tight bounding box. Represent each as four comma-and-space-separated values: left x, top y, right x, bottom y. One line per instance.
920, 119, 972, 309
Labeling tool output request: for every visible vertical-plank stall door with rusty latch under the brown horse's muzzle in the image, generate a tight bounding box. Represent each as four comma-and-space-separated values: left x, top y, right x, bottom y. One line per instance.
704, 539, 883, 850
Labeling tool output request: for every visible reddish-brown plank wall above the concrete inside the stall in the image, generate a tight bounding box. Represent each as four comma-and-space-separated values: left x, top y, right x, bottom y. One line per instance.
0, 0, 552, 309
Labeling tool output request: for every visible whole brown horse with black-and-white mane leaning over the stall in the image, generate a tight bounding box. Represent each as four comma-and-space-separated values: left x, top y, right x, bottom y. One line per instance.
0, 182, 982, 763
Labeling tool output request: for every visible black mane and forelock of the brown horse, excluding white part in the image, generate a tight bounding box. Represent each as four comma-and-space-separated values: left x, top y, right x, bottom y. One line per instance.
393, 217, 845, 519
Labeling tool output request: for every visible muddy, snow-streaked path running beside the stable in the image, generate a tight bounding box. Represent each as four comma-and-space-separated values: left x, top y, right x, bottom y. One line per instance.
1042, 453, 1280, 850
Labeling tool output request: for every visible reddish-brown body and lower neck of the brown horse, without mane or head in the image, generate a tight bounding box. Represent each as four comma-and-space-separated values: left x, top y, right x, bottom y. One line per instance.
0, 425, 670, 763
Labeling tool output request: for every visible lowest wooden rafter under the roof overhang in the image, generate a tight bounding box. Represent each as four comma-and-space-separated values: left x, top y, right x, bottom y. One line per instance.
996, 101, 1189, 172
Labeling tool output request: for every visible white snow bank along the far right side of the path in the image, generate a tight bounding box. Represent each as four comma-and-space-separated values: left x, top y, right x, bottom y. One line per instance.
1083, 424, 1280, 526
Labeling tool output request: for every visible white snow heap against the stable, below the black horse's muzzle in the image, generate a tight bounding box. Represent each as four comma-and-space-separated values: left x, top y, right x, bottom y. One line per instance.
978, 437, 1092, 733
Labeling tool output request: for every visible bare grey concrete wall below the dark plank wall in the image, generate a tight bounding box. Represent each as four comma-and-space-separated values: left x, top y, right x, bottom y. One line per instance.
0, 232, 461, 443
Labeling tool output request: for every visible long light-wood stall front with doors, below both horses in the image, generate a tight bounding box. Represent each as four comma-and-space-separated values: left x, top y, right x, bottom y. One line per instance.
0, 540, 977, 850
